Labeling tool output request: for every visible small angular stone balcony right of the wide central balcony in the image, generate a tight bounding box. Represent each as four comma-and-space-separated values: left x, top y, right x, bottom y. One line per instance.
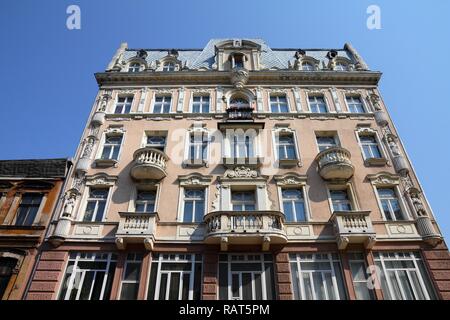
330, 211, 376, 250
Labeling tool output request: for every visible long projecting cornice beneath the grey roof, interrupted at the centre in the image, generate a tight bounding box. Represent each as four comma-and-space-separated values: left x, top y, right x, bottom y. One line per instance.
95, 70, 382, 86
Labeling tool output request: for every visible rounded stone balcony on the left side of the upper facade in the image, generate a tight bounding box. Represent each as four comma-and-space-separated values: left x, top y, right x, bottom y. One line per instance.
130, 148, 169, 180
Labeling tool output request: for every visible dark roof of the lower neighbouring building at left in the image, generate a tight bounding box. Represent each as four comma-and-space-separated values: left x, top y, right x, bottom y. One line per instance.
0, 158, 69, 178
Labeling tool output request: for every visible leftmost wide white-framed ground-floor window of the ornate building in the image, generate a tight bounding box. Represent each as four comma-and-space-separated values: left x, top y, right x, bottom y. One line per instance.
59, 252, 117, 300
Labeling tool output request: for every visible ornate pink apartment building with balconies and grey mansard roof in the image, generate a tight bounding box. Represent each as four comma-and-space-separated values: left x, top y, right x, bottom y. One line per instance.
24, 39, 450, 300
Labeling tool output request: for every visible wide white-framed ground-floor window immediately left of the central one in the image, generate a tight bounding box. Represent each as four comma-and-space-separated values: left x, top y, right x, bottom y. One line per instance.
147, 253, 202, 300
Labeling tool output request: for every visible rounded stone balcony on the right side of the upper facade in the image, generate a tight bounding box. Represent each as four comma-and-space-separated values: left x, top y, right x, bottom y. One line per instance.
316, 147, 355, 180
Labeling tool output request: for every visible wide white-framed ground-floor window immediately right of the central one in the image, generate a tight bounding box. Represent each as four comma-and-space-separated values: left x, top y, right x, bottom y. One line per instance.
289, 253, 347, 300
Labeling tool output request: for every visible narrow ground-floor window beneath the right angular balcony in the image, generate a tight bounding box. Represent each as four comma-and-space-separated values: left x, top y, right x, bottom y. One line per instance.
348, 253, 375, 300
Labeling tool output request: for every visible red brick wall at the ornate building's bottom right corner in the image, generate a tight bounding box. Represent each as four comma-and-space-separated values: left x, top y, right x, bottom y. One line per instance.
423, 242, 450, 300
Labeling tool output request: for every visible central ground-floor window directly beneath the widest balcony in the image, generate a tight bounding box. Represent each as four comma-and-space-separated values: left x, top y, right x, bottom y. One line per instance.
219, 254, 275, 300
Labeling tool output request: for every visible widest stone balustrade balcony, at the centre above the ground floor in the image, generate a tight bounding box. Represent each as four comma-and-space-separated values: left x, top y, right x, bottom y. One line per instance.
204, 211, 287, 251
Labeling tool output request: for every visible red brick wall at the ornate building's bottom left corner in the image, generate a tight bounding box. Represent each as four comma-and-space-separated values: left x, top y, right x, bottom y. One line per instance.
25, 251, 67, 300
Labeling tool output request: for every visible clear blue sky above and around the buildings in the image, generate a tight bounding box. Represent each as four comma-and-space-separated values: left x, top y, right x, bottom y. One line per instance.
0, 0, 450, 238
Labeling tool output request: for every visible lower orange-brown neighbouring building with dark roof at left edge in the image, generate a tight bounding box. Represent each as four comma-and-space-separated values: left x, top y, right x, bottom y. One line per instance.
0, 159, 70, 300
